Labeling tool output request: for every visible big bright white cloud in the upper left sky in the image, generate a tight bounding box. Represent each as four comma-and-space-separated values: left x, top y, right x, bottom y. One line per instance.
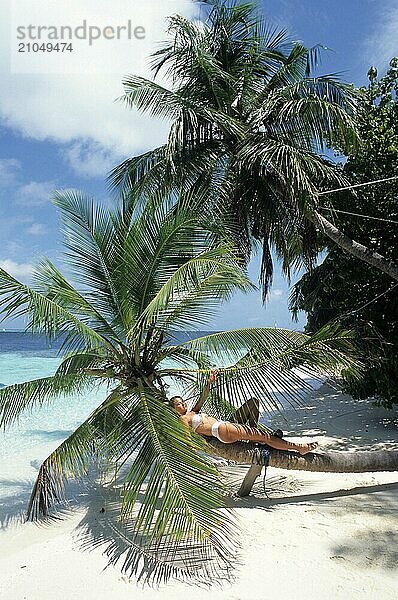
0, 0, 197, 175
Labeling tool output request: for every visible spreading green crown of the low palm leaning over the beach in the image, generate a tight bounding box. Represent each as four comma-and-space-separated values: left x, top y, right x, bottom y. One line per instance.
0, 191, 355, 578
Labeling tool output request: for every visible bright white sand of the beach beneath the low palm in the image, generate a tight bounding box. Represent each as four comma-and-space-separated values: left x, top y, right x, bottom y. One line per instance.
0, 387, 398, 600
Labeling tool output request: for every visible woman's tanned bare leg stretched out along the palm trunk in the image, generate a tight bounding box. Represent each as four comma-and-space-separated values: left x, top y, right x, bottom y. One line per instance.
219, 423, 318, 454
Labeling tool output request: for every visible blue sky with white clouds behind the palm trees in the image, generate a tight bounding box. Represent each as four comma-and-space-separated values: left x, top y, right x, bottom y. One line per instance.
0, 0, 398, 329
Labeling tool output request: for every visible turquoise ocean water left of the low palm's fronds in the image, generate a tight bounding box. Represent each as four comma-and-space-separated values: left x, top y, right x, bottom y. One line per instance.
0, 331, 109, 516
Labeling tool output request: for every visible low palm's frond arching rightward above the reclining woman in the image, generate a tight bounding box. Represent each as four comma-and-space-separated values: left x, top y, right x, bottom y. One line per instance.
174, 325, 360, 418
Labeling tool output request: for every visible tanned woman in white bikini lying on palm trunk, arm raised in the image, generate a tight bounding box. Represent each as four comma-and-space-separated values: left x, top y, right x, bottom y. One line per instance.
169, 371, 318, 455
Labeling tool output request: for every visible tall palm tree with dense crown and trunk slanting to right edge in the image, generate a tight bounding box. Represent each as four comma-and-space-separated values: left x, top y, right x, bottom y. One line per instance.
110, 0, 398, 296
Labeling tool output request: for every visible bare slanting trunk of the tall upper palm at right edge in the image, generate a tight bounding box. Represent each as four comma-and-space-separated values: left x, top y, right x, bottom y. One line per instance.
307, 211, 398, 281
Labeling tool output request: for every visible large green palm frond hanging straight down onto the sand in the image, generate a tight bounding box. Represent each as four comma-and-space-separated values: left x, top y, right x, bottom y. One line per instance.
112, 391, 235, 572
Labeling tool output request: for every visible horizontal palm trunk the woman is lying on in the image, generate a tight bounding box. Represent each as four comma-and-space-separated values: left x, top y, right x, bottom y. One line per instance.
207, 438, 398, 473
